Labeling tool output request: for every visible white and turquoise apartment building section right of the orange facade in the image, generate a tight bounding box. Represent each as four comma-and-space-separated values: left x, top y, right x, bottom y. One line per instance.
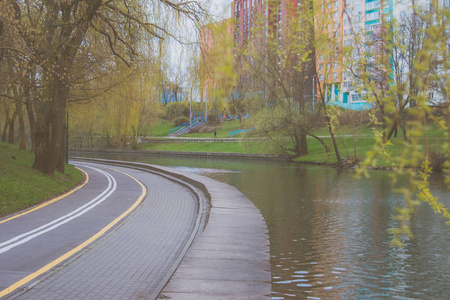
328, 0, 450, 109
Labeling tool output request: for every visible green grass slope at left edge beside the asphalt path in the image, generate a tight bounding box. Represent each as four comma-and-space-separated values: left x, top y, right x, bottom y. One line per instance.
0, 143, 83, 217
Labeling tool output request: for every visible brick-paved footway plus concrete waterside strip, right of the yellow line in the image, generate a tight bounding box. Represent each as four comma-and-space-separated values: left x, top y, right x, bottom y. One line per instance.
0, 160, 271, 299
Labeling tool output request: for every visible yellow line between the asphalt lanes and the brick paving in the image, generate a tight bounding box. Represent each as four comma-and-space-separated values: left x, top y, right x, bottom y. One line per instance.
0, 169, 147, 298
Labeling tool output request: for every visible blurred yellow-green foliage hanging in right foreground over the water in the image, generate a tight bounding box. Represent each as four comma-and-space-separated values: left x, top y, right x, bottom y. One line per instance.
352, 6, 450, 246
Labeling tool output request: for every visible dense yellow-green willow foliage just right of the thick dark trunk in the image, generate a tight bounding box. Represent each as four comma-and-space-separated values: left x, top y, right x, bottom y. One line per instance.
69, 58, 162, 148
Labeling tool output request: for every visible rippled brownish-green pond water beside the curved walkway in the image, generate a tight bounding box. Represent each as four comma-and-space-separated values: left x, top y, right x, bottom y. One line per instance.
74, 155, 450, 299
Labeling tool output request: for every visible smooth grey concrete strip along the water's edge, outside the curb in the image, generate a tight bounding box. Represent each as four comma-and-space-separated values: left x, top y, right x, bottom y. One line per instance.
159, 165, 271, 300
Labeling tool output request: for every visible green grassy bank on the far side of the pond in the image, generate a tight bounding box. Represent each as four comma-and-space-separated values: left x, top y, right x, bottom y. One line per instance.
140, 121, 445, 167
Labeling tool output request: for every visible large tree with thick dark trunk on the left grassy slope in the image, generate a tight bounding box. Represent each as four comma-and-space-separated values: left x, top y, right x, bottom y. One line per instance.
2, 0, 203, 175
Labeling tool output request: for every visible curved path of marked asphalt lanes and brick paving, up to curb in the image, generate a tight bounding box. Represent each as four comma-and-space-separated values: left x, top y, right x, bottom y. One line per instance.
0, 162, 199, 299
